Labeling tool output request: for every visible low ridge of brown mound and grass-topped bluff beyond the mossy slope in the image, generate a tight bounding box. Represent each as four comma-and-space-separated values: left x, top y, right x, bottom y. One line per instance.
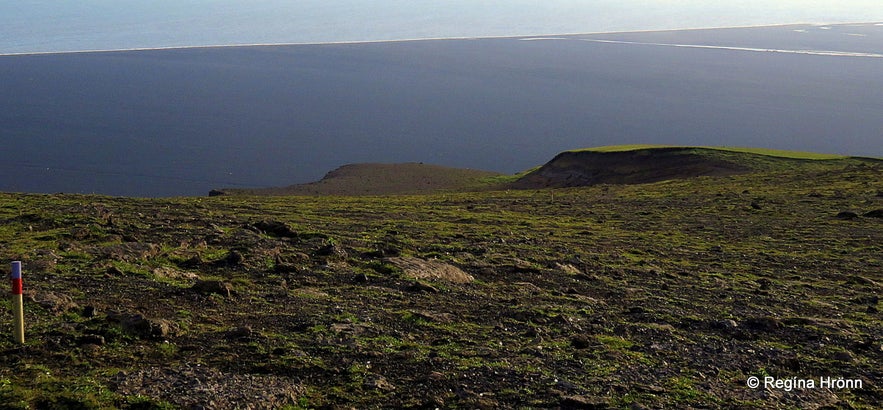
209, 145, 883, 196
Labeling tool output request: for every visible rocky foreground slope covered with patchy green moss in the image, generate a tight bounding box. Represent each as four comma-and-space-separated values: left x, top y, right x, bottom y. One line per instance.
0, 161, 883, 409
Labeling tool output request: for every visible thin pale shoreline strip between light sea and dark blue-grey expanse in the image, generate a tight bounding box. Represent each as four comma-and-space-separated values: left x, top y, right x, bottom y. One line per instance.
0, 21, 883, 57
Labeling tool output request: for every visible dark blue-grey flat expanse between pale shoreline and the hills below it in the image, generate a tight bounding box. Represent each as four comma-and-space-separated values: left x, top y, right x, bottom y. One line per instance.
0, 23, 883, 196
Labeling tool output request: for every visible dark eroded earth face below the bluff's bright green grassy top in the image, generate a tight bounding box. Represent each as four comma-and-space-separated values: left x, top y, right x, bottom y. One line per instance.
514, 148, 749, 189
